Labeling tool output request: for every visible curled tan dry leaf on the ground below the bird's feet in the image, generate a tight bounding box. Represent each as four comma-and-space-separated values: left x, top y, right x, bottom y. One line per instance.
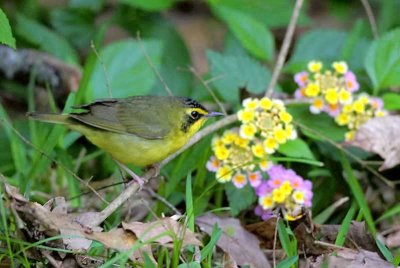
122, 218, 202, 246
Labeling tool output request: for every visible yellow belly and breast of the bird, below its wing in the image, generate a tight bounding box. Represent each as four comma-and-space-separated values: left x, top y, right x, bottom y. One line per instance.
72, 127, 190, 167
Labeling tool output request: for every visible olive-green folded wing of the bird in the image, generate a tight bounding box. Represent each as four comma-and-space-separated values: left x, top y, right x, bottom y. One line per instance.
70, 97, 173, 139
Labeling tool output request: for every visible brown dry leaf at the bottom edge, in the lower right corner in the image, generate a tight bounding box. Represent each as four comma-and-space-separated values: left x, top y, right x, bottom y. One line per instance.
311, 249, 393, 268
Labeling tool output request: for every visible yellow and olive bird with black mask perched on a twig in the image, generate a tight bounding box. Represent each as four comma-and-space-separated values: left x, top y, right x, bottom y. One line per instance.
27, 96, 223, 185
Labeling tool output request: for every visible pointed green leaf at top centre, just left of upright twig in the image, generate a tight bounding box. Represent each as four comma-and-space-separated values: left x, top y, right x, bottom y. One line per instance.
211, 1, 275, 60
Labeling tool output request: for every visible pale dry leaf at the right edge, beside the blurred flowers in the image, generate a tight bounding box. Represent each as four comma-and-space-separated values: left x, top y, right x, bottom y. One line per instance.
347, 116, 400, 171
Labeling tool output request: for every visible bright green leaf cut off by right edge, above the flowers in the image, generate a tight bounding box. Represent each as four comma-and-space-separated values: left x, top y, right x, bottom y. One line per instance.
365, 28, 400, 91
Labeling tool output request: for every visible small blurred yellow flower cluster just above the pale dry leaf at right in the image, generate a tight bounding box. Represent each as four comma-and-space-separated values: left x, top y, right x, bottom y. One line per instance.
335, 94, 386, 141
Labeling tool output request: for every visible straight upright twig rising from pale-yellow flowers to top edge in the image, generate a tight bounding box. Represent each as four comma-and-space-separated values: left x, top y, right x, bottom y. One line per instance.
265, 0, 303, 97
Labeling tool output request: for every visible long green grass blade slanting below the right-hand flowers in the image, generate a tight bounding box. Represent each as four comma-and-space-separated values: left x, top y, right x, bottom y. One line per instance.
340, 152, 377, 236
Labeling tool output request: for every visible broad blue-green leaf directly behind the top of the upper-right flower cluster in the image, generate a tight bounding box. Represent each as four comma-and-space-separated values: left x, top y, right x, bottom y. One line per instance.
286, 29, 369, 73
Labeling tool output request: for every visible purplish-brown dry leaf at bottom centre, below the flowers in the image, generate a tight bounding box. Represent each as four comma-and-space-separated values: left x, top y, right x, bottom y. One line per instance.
196, 213, 270, 268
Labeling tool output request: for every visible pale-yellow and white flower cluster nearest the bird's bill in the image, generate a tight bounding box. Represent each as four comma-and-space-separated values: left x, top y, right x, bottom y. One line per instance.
237, 98, 297, 154
